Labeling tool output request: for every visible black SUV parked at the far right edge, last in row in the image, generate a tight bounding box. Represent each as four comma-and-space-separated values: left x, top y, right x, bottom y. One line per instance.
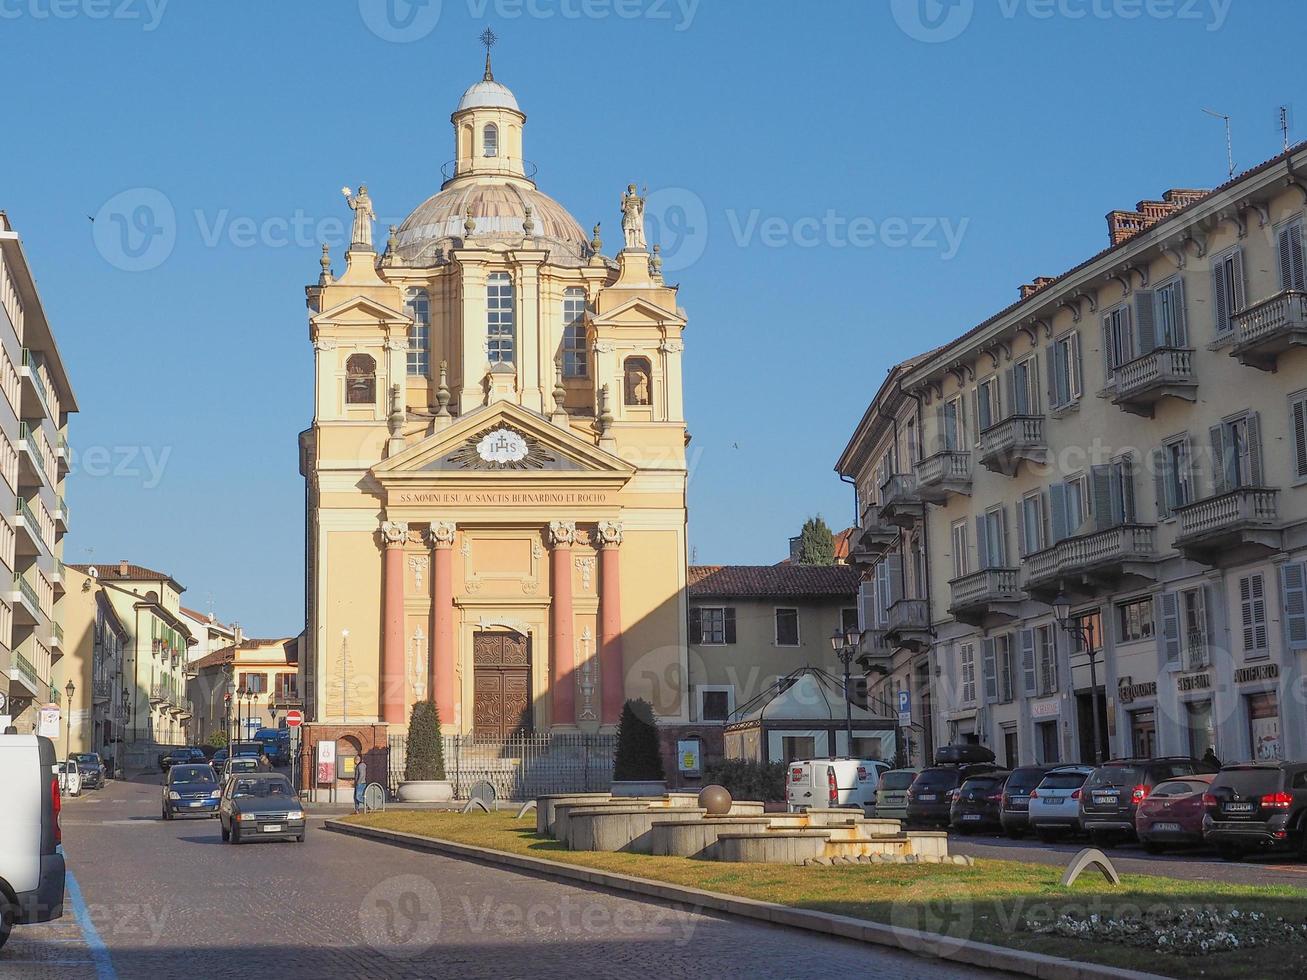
1202, 762, 1307, 861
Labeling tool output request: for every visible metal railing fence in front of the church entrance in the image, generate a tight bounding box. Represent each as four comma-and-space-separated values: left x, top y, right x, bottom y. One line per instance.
388, 734, 617, 800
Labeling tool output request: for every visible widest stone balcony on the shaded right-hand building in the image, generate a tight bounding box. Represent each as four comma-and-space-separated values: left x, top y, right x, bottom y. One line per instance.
1021, 524, 1158, 602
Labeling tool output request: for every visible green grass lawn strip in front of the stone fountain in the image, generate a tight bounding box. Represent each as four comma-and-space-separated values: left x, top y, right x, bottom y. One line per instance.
345, 810, 1307, 980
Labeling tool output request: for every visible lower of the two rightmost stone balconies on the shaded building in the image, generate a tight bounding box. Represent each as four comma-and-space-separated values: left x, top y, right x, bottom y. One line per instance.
1175, 487, 1283, 567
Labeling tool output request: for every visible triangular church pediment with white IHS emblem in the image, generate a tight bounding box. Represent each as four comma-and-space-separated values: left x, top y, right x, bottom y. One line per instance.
372, 401, 635, 483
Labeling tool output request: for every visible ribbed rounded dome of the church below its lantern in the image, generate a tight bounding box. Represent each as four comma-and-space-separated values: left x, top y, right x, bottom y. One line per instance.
396, 182, 589, 265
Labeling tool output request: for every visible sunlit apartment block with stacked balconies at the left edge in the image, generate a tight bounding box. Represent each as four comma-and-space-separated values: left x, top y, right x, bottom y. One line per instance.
0, 212, 76, 732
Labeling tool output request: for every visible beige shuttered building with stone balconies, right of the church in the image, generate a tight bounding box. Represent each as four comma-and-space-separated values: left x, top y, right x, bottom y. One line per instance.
836, 146, 1307, 764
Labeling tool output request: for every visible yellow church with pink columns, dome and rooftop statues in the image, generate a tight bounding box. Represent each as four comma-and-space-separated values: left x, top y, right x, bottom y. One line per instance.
299, 57, 689, 740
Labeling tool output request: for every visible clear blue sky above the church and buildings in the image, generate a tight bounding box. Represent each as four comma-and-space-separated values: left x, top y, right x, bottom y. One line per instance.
0, 0, 1307, 634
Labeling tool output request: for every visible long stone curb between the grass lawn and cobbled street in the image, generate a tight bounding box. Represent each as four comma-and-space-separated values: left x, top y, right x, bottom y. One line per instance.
324, 821, 1162, 980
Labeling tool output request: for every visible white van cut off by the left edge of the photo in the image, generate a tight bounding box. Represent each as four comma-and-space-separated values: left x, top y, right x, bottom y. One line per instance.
0, 734, 64, 946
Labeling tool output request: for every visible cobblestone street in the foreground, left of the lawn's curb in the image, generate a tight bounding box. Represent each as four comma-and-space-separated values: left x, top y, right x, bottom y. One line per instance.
0, 781, 980, 980
